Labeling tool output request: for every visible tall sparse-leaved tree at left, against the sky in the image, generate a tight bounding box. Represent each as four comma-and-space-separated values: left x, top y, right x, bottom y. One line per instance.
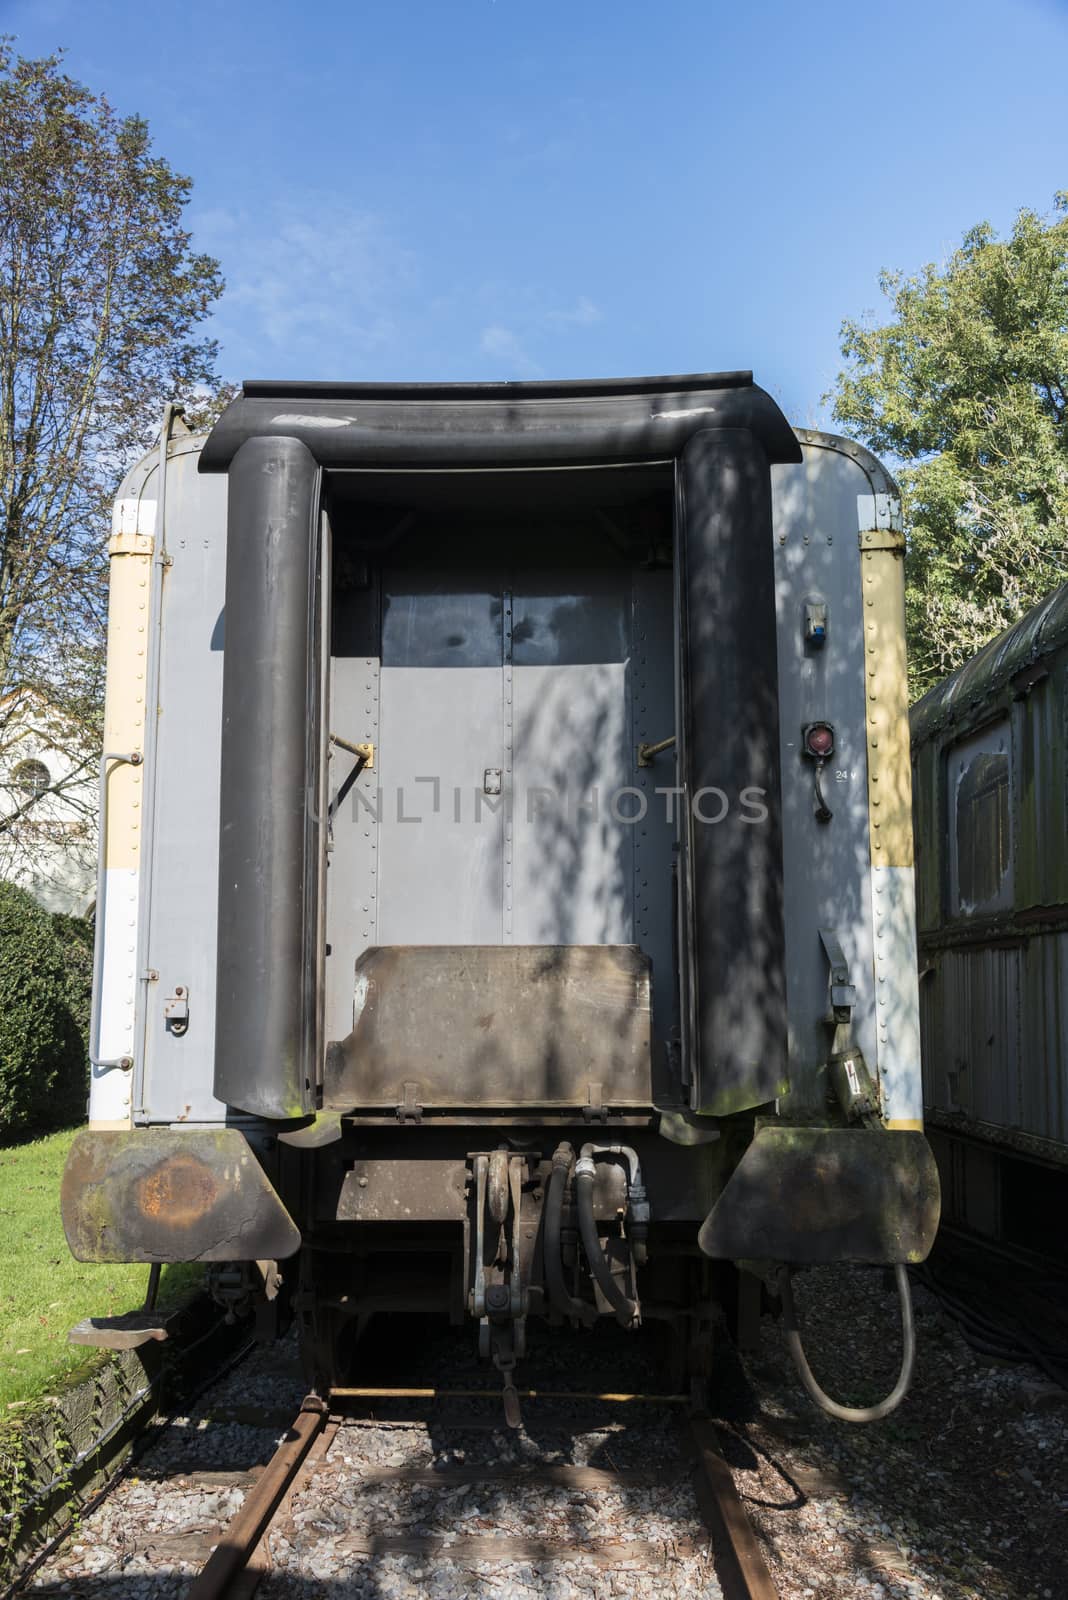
0, 40, 222, 876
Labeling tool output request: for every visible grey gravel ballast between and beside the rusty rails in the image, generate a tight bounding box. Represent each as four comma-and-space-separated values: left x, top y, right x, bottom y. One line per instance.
18, 1269, 1068, 1600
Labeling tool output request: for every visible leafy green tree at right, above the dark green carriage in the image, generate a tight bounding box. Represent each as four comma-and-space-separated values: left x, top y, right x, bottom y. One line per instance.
828, 194, 1068, 694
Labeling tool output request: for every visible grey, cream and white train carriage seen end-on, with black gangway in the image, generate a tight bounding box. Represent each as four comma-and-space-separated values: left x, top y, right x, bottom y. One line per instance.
62, 373, 938, 1418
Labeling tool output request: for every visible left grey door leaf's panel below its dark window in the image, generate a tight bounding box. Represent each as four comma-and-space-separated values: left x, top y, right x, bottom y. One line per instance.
377, 664, 504, 960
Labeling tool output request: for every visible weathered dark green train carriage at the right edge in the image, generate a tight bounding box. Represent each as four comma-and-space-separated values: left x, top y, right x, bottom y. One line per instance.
911, 584, 1068, 1261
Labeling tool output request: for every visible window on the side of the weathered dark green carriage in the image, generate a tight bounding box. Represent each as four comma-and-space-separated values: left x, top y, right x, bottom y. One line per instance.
948, 722, 1012, 917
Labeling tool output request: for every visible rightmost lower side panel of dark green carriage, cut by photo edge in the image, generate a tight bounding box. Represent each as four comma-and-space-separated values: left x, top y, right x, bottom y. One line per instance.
1020, 933, 1068, 1144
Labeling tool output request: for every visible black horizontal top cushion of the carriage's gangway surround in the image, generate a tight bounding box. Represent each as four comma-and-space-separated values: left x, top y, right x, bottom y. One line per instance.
200, 373, 801, 472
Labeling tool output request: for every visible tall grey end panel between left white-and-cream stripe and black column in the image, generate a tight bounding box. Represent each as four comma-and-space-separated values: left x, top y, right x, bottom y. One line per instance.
141, 442, 225, 1122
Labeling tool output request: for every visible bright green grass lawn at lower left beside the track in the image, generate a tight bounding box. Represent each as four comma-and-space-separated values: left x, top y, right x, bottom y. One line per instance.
0, 1128, 203, 1416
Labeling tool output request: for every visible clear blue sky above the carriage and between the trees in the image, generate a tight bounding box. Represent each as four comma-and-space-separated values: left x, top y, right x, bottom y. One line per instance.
0, 0, 1068, 424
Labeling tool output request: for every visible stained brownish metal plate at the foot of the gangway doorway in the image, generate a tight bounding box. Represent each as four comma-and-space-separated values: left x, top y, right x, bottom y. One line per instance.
325, 944, 652, 1110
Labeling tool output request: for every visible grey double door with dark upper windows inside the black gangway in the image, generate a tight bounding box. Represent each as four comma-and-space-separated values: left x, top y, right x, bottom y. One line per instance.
377, 570, 633, 944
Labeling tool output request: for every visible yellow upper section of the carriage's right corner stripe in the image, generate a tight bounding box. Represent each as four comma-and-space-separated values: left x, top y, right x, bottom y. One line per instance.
860, 528, 913, 867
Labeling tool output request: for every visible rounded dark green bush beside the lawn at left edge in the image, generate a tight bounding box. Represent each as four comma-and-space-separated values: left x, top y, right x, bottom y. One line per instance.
0, 883, 91, 1138
